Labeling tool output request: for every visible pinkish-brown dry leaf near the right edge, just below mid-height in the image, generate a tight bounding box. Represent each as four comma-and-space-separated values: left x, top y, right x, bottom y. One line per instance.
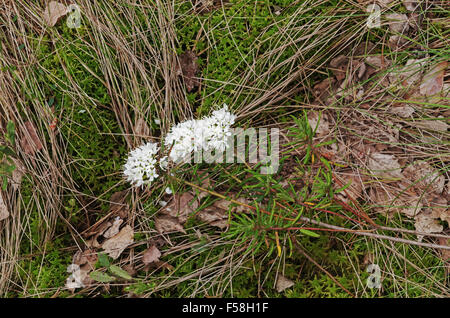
402, 161, 445, 194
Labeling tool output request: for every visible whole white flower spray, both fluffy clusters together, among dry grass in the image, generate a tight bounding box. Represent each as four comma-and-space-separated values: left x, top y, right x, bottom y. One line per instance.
124, 105, 236, 187
